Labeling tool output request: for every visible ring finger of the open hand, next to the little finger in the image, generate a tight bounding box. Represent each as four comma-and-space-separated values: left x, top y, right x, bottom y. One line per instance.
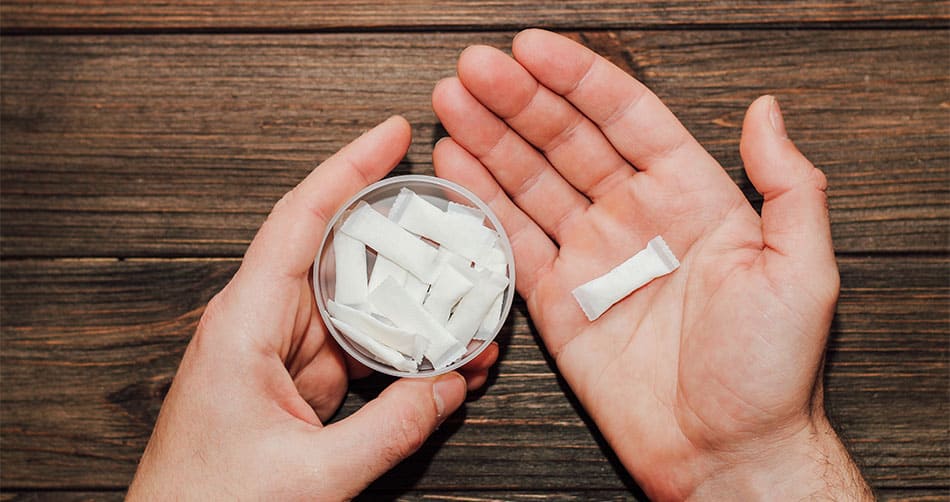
432, 78, 590, 240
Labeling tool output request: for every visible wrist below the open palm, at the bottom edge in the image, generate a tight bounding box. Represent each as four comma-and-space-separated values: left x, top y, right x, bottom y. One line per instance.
689, 415, 873, 500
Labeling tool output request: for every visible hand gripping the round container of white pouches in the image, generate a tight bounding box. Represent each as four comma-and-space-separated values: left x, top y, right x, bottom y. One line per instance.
129, 117, 498, 500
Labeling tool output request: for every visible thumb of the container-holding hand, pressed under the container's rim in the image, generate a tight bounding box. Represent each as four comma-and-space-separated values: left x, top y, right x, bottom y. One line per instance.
323, 372, 466, 491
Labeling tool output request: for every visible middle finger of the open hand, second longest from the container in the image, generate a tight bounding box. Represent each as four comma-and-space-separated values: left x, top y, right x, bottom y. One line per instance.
458, 45, 634, 200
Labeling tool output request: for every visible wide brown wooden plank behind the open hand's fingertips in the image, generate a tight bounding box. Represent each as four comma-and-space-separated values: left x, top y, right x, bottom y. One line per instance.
0, 31, 950, 257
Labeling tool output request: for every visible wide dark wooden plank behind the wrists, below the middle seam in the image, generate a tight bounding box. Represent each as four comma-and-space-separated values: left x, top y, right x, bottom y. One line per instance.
0, 257, 950, 492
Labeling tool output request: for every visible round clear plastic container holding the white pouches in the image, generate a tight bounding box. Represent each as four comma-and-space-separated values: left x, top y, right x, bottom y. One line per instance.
313, 175, 515, 377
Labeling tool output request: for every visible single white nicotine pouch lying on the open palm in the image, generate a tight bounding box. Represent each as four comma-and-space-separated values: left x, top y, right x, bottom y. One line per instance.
571, 236, 680, 321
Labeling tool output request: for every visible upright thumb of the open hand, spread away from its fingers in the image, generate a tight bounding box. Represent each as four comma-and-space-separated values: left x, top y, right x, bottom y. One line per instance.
739, 96, 837, 294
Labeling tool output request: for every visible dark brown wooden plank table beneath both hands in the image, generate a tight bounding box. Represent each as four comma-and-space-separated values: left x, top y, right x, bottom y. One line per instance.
0, 0, 950, 500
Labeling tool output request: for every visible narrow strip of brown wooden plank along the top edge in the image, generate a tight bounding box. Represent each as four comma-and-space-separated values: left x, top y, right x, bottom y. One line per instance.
0, 0, 950, 31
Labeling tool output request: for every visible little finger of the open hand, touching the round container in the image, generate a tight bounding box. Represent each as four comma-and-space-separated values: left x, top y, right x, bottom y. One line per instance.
432, 138, 558, 298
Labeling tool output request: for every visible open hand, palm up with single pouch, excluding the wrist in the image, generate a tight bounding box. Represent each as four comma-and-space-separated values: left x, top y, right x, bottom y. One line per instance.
433, 30, 838, 498
